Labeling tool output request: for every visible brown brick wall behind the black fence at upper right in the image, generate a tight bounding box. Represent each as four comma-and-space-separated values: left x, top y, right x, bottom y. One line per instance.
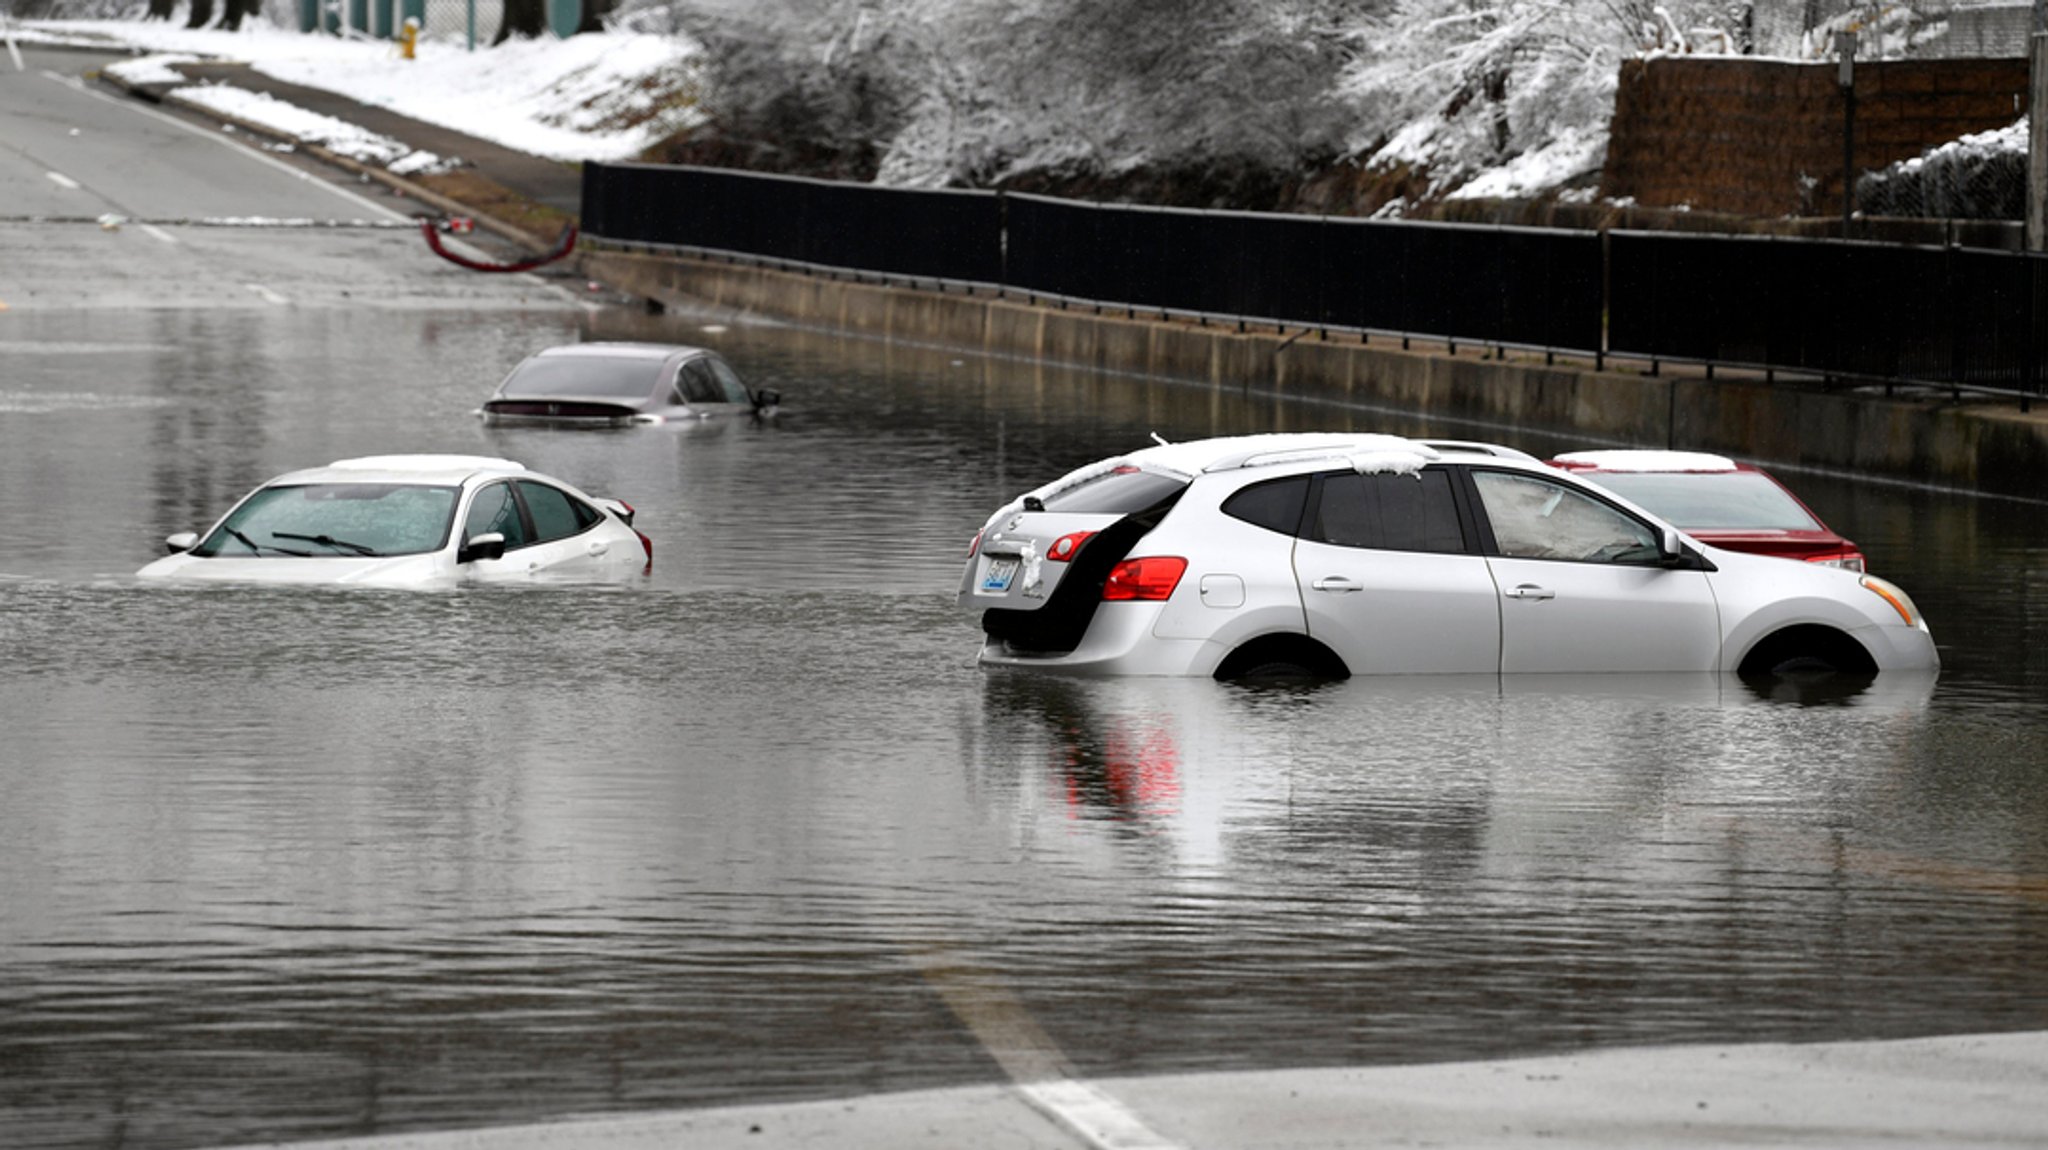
1599, 57, 2028, 217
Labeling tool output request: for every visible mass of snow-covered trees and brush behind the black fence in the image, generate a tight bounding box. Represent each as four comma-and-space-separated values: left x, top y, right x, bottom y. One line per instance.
627, 0, 1798, 207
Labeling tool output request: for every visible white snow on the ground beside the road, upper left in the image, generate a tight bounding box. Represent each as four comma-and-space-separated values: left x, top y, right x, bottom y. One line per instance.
12, 18, 702, 162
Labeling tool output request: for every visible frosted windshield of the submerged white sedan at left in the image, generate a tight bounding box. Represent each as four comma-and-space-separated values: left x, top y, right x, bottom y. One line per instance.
193, 483, 461, 559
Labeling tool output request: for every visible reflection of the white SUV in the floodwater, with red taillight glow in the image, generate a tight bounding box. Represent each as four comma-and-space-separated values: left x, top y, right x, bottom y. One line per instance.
981, 671, 1935, 872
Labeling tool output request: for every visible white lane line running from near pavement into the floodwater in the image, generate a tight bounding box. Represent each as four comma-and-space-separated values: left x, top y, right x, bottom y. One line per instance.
909, 947, 1184, 1150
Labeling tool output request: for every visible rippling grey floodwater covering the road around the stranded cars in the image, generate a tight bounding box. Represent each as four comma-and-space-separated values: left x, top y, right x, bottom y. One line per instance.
0, 311, 2048, 1146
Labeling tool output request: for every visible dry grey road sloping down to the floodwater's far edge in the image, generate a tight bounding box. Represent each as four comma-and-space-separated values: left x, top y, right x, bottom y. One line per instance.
0, 49, 575, 311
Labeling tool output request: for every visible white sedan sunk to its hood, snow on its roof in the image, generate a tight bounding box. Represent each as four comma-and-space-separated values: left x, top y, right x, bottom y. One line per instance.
137, 454, 653, 587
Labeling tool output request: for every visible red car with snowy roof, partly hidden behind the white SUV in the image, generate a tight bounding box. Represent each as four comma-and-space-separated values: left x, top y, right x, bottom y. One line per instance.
1550, 450, 1864, 571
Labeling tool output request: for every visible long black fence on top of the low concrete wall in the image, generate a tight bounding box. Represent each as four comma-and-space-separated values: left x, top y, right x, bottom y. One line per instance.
582, 164, 2048, 395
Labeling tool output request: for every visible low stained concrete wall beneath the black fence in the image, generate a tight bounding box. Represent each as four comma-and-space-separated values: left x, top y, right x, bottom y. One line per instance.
582, 252, 2048, 497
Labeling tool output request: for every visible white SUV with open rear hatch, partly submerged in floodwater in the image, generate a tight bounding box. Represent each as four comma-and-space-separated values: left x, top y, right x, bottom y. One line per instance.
958, 434, 1939, 679
